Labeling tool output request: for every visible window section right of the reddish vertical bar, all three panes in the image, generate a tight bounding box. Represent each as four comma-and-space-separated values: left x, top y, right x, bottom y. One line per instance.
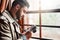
41, 0, 60, 40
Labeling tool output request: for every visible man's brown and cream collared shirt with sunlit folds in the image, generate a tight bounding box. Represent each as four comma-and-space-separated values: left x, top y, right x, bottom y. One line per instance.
0, 10, 20, 40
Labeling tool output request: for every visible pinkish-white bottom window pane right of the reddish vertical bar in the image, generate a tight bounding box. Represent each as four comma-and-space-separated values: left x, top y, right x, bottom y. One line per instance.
42, 27, 60, 40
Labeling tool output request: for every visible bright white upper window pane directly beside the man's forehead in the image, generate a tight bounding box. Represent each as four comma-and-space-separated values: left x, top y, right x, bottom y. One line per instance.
27, 0, 39, 11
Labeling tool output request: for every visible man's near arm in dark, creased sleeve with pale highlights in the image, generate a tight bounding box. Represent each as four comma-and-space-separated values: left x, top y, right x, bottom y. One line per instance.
0, 20, 12, 40
